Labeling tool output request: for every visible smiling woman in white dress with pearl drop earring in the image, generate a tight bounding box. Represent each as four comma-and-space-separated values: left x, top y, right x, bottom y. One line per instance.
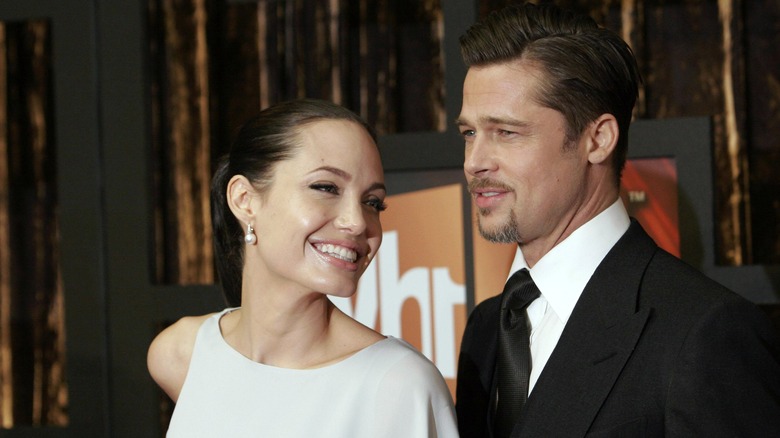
148, 100, 457, 437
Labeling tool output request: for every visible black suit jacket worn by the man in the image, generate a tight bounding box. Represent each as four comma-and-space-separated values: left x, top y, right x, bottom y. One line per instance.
456, 221, 780, 438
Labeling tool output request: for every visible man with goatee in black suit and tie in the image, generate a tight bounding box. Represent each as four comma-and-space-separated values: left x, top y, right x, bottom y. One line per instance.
456, 1, 780, 437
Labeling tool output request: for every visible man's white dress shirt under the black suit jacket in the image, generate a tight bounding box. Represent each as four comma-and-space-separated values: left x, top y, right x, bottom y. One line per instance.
509, 198, 631, 394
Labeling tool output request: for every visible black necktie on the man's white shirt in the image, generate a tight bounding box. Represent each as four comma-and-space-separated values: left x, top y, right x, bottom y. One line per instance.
493, 268, 540, 437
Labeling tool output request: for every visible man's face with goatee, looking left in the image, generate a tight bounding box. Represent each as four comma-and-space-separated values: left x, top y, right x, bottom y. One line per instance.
458, 61, 588, 255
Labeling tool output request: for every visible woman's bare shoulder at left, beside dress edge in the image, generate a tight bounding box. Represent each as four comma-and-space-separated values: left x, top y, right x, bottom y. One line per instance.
146, 314, 213, 402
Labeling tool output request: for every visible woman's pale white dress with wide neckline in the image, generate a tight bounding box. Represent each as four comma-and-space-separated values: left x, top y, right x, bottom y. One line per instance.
167, 309, 458, 438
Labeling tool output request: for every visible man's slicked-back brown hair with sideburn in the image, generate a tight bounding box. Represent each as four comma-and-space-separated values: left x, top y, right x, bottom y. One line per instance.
460, 3, 642, 184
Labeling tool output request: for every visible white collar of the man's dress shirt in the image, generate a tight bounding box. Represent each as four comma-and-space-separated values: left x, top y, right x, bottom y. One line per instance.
509, 198, 631, 323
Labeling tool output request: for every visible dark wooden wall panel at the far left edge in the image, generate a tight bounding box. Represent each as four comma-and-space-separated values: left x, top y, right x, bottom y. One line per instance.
0, 20, 68, 428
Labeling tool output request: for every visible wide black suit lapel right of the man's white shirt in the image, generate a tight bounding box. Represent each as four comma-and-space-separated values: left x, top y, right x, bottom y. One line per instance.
512, 221, 657, 437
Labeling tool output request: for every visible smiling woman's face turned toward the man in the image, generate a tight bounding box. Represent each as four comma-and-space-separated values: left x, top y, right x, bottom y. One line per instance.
244, 120, 386, 296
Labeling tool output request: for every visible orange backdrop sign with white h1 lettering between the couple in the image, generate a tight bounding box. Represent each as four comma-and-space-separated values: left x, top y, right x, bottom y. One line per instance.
334, 184, 466, 391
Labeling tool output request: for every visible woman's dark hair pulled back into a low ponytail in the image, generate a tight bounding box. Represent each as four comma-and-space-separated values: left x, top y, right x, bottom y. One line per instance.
211, 99, 376, 307
